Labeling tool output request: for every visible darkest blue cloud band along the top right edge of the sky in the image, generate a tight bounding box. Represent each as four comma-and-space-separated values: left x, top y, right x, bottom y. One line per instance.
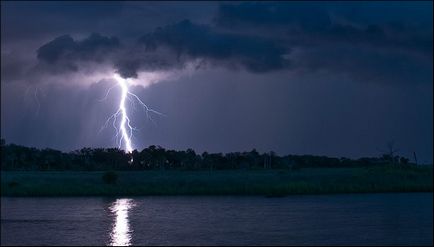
213, 1, 432, 31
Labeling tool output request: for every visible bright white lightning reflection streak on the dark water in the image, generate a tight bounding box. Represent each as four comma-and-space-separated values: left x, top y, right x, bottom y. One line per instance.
109, 199, 135, 246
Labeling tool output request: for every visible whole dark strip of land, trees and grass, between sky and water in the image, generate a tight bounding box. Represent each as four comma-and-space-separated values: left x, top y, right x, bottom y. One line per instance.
1, 139, 433, 197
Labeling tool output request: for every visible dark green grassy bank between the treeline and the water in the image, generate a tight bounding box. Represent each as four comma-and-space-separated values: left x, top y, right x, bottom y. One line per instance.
1, 166, 433, 196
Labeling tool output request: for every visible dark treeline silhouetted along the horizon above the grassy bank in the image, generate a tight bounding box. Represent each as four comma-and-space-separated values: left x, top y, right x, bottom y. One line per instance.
1, 140, 409, 171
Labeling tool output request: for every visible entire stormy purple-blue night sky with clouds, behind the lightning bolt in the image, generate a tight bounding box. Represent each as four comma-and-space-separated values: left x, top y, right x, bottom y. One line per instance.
1, 1, 433, 163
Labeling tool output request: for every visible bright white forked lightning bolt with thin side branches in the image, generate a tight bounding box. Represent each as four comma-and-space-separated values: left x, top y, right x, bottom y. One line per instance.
100, 74, 165, 153
